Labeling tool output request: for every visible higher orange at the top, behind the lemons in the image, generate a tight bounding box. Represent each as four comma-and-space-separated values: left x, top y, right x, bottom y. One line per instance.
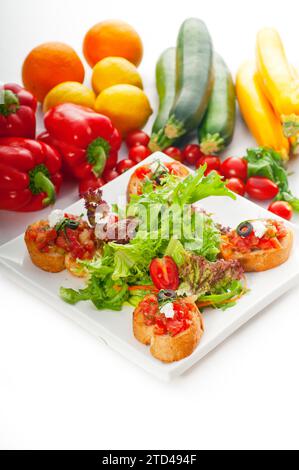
83, 20, 143, 67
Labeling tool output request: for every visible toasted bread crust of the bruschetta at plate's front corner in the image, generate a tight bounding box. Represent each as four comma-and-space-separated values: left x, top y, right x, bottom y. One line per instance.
133, 304, 204, 363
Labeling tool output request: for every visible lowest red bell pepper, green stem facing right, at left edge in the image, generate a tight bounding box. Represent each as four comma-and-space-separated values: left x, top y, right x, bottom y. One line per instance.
0, 137, 62, 212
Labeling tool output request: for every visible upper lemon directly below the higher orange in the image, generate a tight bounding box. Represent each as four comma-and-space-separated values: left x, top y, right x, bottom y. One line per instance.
91, 57, 143, 94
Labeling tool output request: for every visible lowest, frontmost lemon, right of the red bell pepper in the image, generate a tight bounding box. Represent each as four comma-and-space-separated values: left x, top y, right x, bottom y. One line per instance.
94, 85, 153, 136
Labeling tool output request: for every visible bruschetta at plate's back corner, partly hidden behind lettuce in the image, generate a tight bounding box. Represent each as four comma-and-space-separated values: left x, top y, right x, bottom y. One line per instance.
127, 160, 189, 199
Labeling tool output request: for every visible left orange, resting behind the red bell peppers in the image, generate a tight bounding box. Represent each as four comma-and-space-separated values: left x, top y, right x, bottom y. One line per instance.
22, 42, 84, 101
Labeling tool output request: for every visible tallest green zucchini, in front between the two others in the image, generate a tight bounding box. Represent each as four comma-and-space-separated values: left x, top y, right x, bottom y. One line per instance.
150, 18, 213, 150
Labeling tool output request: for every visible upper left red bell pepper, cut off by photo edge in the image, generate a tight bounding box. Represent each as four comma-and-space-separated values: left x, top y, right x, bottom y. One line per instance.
0, 83, 37, 139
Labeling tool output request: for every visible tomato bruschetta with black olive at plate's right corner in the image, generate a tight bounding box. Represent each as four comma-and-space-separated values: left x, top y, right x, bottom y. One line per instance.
221, 219, 293, 272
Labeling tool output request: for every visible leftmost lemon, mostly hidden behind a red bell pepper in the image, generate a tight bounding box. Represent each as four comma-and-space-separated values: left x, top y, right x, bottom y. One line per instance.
43, 82, 95, 112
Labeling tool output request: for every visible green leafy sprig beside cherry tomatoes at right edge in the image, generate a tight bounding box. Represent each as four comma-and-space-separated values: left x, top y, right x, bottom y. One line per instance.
245, 147, 299, 211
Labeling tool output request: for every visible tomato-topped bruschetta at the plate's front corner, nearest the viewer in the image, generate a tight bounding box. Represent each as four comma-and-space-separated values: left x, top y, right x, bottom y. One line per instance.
133, 294, 204, 363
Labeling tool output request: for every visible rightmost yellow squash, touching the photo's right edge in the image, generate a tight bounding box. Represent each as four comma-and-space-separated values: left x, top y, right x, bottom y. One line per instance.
256, 28, 299, 137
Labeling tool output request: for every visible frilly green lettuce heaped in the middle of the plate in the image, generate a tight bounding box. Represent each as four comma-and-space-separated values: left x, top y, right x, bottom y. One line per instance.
60, 160, 244, 310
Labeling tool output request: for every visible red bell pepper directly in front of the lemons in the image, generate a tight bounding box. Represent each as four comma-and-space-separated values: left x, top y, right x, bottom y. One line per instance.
38, 103, 121, 180
